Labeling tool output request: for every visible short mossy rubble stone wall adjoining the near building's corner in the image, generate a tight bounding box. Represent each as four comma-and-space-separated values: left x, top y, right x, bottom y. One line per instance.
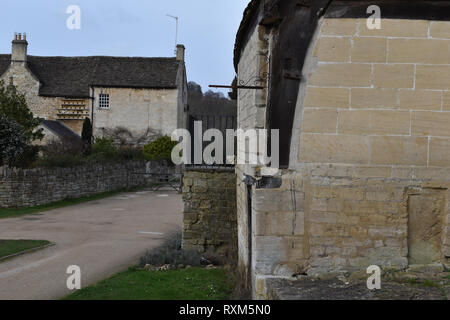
183, 168, 237, 260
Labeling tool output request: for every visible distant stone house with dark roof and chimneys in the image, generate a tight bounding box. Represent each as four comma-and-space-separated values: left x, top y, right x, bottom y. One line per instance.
0, 34, 187, 141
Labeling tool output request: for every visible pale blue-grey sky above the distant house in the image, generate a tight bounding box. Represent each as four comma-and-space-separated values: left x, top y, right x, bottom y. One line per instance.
0, 0, 249, 95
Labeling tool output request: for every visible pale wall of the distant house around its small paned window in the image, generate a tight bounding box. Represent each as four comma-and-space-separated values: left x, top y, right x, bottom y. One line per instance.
93, 87, 178, 136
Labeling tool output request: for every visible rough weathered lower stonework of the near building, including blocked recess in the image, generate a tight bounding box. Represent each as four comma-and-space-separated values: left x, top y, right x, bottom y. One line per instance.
252, 164, 450, 298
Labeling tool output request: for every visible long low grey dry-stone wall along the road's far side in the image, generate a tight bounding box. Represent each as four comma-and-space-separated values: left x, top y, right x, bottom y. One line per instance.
0, 162, 146, 208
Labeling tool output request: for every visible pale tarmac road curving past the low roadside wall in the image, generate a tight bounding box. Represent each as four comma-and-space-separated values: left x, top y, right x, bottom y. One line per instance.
0, 191, 183, 300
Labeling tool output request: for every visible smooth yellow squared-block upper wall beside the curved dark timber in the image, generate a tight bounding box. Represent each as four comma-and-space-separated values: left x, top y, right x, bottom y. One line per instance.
298, 19, 450, 167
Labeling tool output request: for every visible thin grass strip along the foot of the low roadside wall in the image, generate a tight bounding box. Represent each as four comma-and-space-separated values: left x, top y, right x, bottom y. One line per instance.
0, 190, 130, 219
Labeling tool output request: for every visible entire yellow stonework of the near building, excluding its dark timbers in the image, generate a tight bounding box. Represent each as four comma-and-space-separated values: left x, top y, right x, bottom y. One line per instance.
237, 19, 450, 298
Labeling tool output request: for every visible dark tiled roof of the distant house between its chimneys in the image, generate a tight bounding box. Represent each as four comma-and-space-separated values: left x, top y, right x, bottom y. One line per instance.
0, 55, 179, 98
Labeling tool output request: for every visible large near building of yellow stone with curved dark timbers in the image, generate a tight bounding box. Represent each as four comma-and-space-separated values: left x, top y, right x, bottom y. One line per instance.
235, 0, 450, 298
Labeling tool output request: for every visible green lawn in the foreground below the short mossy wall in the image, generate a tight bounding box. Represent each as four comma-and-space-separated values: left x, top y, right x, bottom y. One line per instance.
65, 268, 233, 300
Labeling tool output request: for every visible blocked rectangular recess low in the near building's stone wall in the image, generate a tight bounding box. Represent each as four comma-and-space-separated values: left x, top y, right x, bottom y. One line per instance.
408, 189, 446, 265
